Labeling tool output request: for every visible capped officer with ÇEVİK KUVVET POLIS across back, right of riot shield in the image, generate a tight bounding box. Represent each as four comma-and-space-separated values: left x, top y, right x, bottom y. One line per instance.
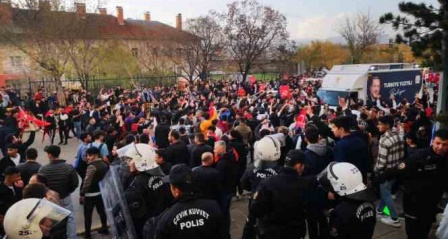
150, 164, 224, 239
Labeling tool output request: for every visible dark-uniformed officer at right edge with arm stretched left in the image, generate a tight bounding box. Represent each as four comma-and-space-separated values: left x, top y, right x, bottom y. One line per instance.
379, 130, 448, 239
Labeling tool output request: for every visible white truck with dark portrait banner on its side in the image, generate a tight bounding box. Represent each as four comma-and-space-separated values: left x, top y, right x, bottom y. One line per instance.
317, 63, 423, 107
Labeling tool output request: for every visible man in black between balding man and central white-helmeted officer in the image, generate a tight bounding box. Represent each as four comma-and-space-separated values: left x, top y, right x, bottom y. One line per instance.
214, 140, 238, 239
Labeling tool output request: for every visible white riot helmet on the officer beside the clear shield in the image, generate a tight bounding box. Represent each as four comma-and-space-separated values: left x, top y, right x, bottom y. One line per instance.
125, 144, 159, 172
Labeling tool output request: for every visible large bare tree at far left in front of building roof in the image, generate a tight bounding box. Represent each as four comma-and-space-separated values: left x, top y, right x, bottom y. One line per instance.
0, 0, 85, 105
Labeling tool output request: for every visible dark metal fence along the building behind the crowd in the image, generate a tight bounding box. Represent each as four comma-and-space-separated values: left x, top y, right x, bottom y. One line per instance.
6, 73, 279, 96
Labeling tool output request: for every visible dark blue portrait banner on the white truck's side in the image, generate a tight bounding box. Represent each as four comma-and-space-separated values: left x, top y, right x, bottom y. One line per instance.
367, 70, 422, 103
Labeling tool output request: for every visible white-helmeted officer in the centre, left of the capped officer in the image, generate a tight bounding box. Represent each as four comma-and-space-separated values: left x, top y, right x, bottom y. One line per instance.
241, 135, 281, 239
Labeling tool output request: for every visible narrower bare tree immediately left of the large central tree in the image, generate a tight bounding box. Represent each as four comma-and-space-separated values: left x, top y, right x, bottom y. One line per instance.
186, 11, 225, 80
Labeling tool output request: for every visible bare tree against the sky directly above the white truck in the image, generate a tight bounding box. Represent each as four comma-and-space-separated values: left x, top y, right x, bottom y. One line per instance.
338, 13, 383, 64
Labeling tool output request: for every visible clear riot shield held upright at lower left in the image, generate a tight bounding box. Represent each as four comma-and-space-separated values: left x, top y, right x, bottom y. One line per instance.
100, 166, 136, 239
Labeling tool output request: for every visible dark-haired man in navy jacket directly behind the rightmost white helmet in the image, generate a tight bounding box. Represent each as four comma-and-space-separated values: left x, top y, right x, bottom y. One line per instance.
330, 116, 371, 180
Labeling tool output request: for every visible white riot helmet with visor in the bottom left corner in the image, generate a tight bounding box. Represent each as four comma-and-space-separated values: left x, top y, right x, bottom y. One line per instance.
3, 198, 70, 239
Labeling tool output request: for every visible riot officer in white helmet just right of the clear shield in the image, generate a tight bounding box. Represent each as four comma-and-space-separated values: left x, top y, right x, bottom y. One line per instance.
125, 144, 172, 238
